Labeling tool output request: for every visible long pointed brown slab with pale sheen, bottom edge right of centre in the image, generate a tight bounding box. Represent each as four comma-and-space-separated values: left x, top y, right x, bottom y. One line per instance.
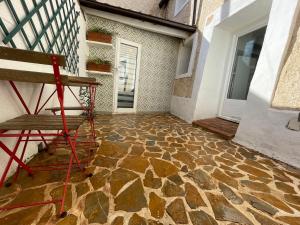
206, 193, 253, 225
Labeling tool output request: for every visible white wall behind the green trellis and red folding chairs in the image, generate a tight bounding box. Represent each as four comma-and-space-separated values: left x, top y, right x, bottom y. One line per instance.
0, 1, 86, 178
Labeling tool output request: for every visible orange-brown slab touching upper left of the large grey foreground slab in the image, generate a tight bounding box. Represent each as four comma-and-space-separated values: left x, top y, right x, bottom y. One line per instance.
109, 168, 138, 196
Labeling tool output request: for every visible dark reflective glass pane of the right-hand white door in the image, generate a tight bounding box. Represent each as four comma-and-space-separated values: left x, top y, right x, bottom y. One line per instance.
227, 27, 266, 100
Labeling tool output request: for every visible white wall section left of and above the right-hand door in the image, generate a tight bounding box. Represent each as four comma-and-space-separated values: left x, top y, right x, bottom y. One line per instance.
171, 0, 271, 122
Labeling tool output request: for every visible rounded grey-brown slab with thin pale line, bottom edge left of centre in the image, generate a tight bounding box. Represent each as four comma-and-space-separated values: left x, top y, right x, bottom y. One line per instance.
83, 191, 109, 224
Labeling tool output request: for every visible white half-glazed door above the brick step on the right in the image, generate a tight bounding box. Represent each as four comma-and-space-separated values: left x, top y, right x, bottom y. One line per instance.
219, 26, 266, 122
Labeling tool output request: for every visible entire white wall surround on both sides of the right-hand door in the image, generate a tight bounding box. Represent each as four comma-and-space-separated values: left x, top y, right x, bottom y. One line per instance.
171, 0, 300, 167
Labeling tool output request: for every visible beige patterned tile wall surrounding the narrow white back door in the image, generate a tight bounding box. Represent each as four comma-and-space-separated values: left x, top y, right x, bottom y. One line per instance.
87, 15, 180, 112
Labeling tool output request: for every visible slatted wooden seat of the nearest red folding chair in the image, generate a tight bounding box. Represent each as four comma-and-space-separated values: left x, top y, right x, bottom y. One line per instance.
0, 115, 85, 130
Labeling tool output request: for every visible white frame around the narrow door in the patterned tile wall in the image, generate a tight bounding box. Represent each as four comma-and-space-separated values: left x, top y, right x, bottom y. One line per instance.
113, 38, 142, 113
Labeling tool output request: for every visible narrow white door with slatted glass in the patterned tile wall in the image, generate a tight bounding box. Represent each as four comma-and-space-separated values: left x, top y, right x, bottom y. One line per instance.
114, 39, 141, 113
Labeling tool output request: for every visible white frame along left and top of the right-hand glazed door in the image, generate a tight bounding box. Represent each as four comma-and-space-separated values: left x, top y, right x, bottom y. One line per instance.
218, 18, 268, 123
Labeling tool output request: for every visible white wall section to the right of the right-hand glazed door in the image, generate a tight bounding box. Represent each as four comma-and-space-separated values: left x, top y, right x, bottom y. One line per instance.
234, 0, 300, 167
